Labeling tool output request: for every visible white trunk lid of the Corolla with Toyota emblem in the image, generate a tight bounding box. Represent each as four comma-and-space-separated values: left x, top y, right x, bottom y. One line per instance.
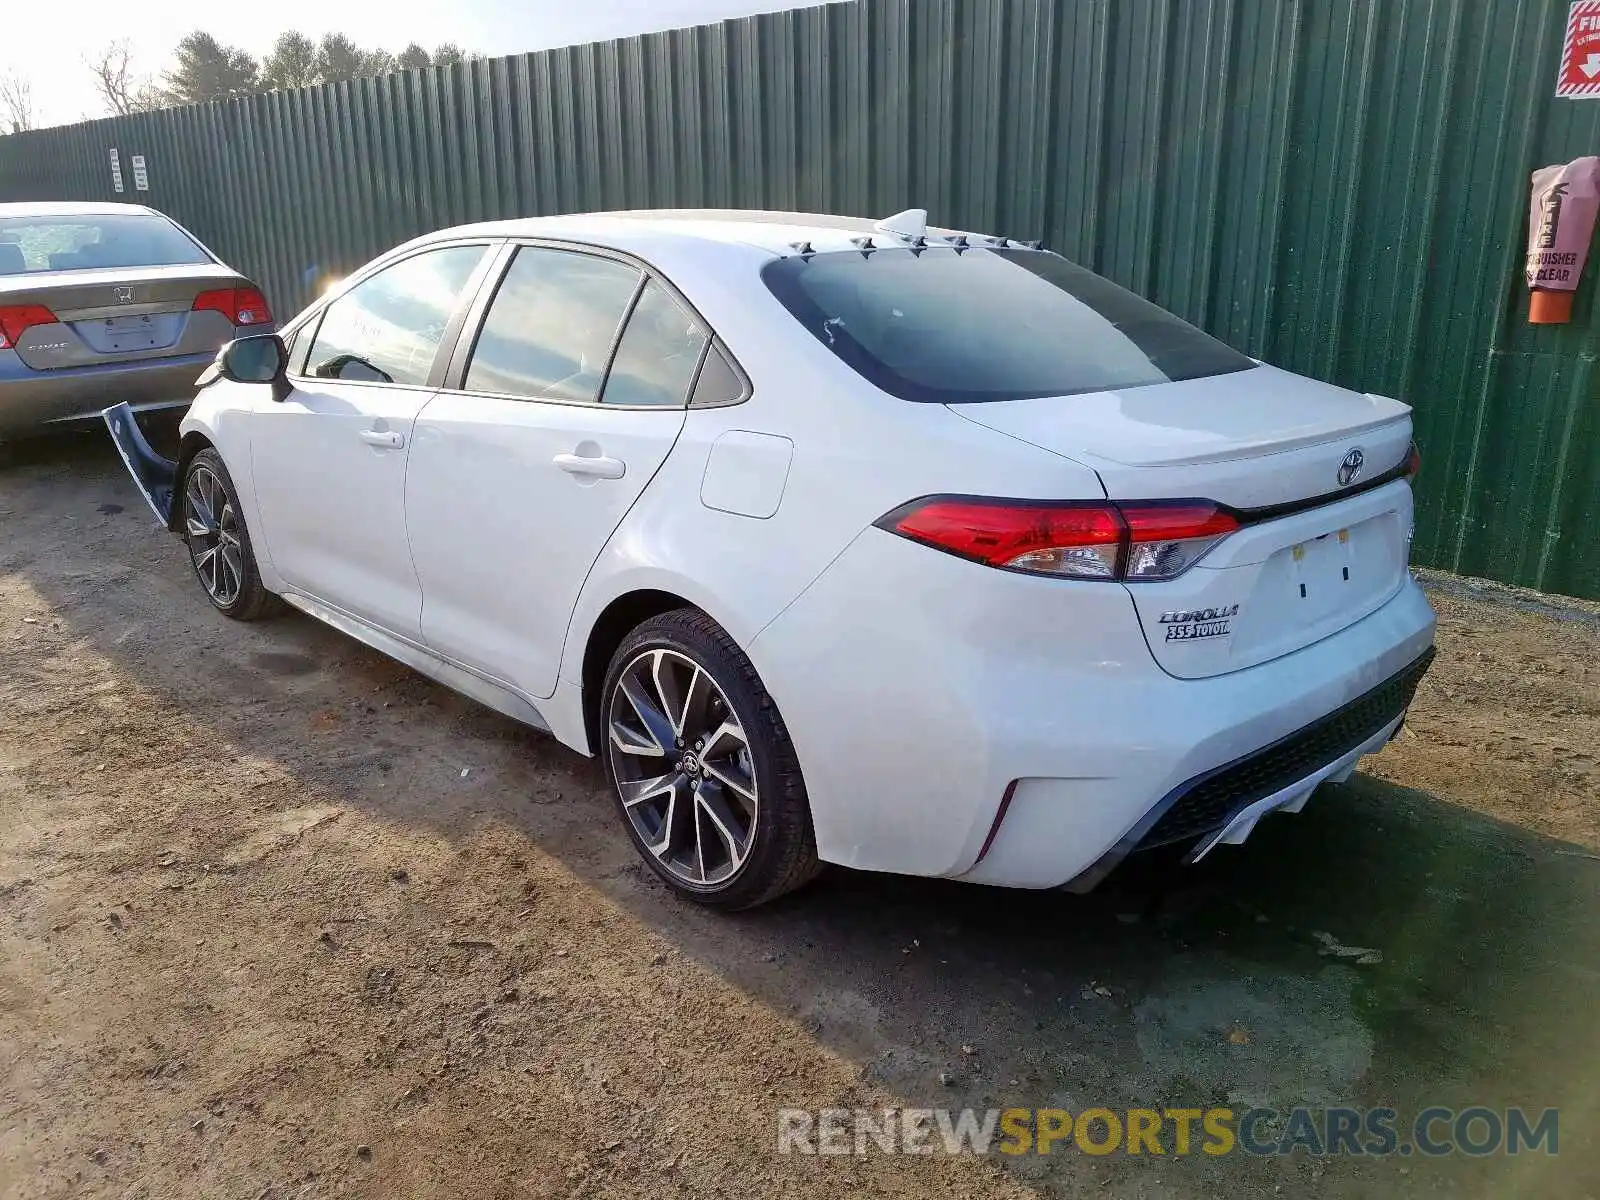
952, 366, 1411, 678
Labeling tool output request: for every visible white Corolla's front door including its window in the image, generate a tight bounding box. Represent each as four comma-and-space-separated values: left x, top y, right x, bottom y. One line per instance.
251, 242, 490, 640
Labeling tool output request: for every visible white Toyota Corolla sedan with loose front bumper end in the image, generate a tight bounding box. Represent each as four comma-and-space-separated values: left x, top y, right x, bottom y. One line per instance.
107, 211, 1434, 907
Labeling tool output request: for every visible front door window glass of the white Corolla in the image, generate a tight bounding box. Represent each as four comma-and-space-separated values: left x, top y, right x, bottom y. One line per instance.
306, 246, 485, 384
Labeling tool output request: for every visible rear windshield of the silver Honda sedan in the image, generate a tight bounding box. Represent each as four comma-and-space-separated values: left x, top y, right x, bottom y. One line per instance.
0, 213, 211, 275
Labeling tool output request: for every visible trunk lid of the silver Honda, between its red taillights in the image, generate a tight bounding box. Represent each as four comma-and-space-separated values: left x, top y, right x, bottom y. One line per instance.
0, 262, 250, 371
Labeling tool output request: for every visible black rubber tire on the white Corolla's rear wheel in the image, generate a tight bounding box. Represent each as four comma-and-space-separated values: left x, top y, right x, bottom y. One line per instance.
597, 608, 821, 910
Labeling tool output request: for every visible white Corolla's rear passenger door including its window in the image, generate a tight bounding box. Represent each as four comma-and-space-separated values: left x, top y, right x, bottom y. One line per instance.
406, 245, 709, 698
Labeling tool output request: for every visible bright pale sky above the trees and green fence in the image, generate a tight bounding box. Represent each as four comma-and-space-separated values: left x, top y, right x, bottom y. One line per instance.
0, 0, 844, 126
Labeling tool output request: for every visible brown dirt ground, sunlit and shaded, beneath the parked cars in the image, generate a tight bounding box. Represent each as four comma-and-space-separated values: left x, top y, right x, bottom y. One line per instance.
0, 438, 1600, 1200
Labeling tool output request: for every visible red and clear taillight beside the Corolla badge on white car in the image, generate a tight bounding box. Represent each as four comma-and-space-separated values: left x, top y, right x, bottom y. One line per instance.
878, 496, 1238, 582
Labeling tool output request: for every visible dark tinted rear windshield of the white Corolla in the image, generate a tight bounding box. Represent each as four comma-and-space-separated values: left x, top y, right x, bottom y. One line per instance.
762, 246, 1254, 405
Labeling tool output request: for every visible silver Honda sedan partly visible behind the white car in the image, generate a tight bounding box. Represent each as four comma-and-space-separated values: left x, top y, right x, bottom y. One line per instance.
0, 203, 274, 442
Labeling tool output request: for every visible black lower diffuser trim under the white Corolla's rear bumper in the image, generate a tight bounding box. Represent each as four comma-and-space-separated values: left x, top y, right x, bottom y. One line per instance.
1067, 646, 1435, 891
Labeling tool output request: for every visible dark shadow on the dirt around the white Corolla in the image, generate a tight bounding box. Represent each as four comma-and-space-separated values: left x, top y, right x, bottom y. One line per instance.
0, 440, 1600, 1195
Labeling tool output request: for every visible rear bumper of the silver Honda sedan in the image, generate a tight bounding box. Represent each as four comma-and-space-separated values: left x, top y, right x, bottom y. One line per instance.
0, 350, 216, 438
